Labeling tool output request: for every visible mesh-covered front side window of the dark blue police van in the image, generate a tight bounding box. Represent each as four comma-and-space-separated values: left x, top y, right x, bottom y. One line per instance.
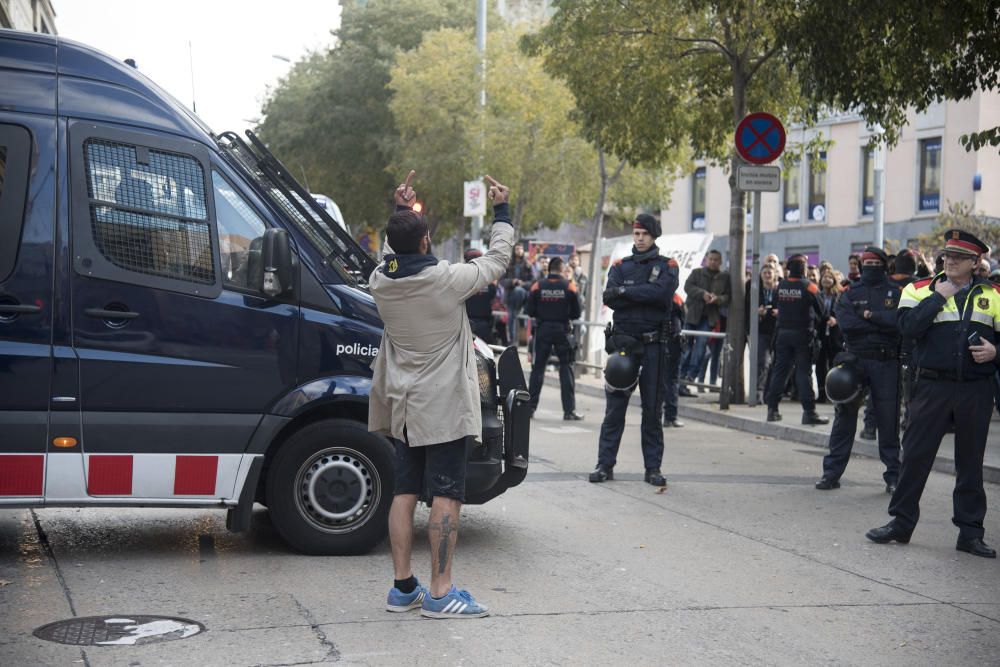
84, 139, 215, 284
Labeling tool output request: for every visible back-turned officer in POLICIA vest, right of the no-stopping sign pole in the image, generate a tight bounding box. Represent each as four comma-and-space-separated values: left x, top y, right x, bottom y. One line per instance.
764, 255, 830, 426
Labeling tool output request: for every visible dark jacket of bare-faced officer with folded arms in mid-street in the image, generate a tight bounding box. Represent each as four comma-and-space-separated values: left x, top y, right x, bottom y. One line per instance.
604, 246, 679, 335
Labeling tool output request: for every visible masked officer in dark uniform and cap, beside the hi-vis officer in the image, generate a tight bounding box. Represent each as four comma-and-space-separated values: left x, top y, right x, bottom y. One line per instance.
816, 246, 901, 493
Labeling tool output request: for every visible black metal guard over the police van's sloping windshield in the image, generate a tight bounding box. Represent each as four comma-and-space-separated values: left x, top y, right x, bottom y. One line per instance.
218, 131, 375, 285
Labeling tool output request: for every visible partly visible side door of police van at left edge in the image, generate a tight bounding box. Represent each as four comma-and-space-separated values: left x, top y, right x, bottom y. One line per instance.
0, 121, 56, 505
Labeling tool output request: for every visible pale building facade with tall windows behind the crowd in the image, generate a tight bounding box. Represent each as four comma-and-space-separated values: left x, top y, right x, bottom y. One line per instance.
661, 91, 1000, 270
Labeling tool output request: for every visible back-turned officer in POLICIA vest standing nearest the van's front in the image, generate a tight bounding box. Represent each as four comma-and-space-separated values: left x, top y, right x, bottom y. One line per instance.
524, 257, 583, 421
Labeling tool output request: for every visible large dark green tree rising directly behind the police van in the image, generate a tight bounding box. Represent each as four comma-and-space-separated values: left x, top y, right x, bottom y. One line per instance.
258, 0, 475, 230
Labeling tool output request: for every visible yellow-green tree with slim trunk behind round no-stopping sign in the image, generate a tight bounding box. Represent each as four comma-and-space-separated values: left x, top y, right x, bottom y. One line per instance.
524, 0, 811, 408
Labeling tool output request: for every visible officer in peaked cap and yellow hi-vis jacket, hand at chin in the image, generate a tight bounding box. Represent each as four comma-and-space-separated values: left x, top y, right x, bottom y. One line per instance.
865, 229, 1000, 558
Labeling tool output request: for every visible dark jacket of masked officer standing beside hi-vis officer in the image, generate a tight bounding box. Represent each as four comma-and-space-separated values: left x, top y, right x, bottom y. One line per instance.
834, 279, 901, 359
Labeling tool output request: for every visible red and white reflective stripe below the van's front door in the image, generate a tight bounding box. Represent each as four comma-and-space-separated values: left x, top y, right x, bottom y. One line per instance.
85, 454, 243, 498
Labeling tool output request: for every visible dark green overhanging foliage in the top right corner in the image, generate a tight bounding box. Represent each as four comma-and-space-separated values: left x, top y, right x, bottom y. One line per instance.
781, 0, 1000, 150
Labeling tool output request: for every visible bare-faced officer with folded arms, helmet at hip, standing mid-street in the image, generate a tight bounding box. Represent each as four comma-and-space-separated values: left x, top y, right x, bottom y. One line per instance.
590, 213, 678, 486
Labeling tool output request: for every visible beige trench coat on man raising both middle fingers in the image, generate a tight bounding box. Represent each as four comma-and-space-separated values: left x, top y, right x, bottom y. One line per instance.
368, 223, 514, 447
